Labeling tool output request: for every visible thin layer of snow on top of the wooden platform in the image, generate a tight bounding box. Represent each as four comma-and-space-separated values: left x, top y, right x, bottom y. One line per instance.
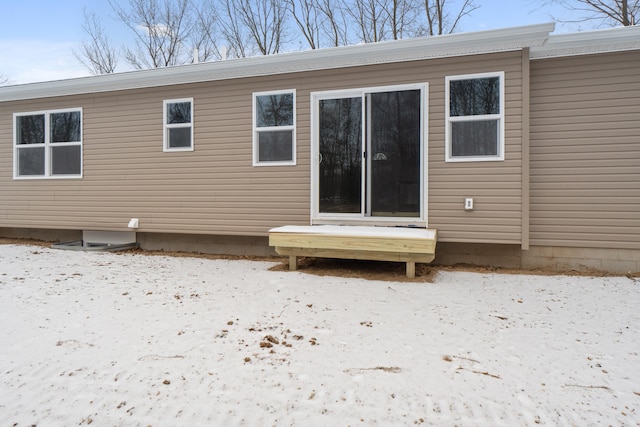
269, 225, 435, 239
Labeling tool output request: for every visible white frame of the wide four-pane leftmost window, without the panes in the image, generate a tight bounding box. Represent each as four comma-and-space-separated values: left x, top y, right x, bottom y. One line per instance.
13, 107, 84, 180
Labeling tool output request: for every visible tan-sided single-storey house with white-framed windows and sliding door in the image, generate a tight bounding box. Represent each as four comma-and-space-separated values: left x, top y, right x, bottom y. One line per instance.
0, 24, 640, 273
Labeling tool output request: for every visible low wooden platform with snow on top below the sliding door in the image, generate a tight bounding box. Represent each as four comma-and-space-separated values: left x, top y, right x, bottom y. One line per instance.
269, 225, 437, 278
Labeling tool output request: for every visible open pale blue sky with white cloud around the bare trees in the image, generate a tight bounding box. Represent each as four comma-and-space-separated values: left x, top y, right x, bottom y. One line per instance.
0, 0, 588, 84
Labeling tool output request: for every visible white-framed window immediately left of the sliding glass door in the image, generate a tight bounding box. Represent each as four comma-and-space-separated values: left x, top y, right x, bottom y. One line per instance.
253, 89, 296, 166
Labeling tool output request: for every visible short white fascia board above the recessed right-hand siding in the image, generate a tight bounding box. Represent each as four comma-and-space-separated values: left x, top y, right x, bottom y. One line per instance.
530, 26, 640, 60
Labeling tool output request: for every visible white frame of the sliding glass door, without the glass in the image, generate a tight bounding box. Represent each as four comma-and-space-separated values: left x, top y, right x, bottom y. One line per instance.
309, 83, 429, 227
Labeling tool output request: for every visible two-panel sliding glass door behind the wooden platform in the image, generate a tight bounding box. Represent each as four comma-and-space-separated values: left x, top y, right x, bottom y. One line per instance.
313, 85, 427, 221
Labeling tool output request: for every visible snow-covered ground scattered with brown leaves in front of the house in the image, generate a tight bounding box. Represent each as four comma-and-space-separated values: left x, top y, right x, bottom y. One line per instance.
0, 245, 640, 427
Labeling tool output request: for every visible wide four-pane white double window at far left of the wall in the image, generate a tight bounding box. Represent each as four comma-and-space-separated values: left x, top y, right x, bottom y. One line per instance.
13, 108, 82, 179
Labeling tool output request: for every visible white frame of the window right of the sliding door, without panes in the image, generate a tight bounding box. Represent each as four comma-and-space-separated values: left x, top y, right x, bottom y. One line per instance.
445, 71, 505, 162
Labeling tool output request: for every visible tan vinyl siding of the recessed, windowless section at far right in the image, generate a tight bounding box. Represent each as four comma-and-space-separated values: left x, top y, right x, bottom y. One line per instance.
531, 51, 640, 249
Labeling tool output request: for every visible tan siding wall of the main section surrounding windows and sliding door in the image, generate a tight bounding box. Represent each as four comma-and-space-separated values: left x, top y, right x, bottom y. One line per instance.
0, 51, 523, 244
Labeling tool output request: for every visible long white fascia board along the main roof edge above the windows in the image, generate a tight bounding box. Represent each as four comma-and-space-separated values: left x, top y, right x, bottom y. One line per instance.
0, 23, 555, 102
